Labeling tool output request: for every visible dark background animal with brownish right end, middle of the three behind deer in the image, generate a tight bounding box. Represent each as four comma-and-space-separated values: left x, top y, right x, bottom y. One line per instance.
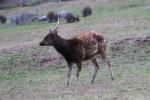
65, 13, 80, 23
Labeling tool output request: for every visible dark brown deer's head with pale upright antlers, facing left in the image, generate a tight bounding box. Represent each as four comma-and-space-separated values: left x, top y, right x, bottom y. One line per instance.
39, 18, 59, 46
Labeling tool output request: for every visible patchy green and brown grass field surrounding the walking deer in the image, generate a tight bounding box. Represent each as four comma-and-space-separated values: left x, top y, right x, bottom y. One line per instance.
0, 0, 150, 100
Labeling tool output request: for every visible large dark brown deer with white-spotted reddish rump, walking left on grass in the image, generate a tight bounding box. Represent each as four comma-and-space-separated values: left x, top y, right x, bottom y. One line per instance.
39, 20, 114, 86
